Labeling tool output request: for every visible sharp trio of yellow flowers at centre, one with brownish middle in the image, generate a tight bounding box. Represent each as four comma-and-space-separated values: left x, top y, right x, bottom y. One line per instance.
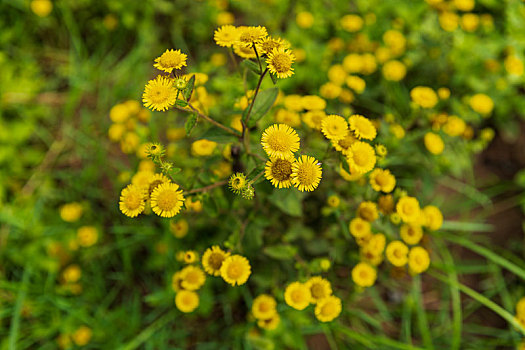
261, 124, 322, 192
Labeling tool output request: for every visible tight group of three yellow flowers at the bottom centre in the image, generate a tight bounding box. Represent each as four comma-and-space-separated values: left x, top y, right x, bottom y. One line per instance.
284, 276, 342, 322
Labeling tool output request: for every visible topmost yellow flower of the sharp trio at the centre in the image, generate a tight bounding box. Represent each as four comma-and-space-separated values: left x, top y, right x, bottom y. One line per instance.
261, 124, 299, 159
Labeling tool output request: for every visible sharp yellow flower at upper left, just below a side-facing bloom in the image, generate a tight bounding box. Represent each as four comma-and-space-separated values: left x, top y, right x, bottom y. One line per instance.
142, 75, 177, 111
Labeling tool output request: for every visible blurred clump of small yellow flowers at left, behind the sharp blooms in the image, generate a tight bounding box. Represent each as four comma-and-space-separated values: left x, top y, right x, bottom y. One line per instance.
108, 100, 150, 154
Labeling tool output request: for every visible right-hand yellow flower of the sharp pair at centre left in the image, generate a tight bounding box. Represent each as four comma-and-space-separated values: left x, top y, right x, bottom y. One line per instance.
151, 183, 184, 218
